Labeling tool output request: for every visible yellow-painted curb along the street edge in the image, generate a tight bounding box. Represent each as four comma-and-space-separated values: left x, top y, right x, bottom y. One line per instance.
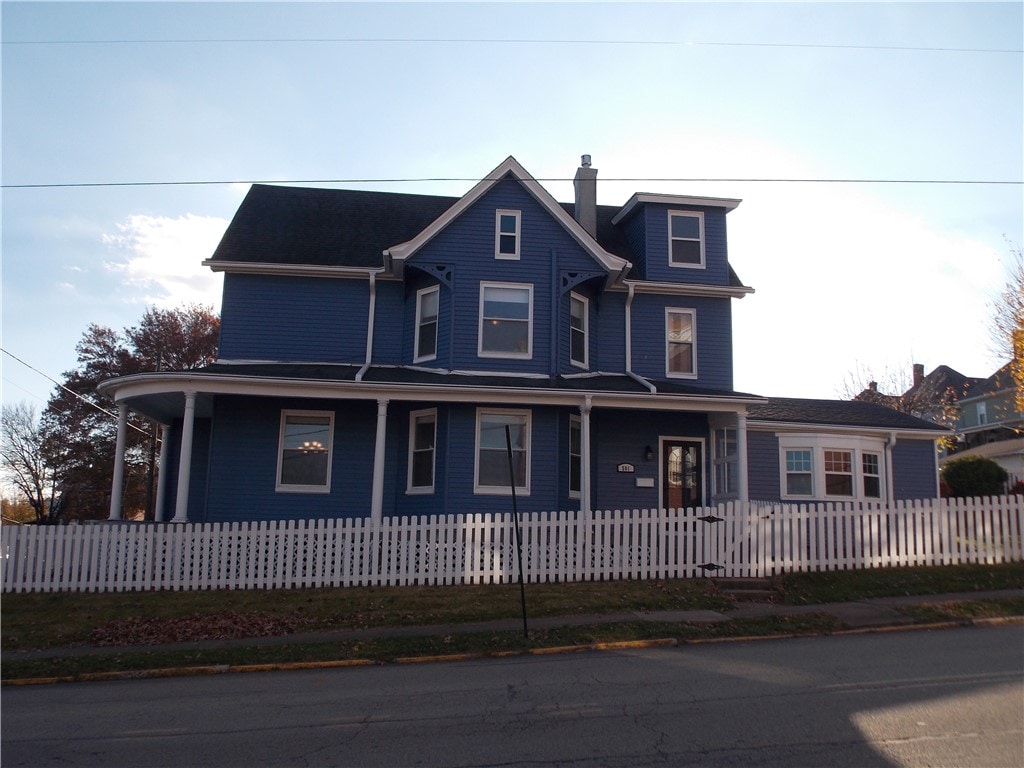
0, 615, 1024, 687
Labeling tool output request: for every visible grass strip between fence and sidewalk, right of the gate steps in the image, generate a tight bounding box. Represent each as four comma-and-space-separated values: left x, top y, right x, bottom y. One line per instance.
779, 562, 1024, 605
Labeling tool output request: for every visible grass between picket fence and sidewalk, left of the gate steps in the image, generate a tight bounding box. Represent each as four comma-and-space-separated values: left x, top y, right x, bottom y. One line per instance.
0, 580, 731, 651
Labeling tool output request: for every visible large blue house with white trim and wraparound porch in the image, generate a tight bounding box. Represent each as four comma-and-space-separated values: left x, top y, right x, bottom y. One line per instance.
100, 156, 945, 521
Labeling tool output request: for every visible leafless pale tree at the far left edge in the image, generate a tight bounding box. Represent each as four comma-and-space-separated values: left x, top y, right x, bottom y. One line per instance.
0, 402, 57, 523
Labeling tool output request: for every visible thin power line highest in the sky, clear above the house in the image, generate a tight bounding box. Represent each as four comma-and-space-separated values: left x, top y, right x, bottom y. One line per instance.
3, 37, 1024, 53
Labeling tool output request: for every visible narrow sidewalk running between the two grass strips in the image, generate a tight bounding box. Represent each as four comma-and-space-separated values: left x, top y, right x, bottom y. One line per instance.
4, 589, 1024, 660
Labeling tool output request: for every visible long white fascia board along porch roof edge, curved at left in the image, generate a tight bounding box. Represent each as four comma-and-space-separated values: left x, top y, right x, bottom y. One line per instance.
97, 373, 764, 413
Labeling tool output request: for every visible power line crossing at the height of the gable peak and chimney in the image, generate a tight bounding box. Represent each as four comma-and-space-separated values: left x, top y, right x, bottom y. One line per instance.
0, 176, 1024, 189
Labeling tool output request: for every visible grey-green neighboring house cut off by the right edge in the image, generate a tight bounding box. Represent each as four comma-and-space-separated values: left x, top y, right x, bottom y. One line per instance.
942, 362, 1024, 486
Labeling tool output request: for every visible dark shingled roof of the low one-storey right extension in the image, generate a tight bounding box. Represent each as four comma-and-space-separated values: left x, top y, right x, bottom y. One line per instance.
748, 397, 947, 432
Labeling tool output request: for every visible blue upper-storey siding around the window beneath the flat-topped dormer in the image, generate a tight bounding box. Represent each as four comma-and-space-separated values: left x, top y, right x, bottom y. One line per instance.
632, 294, 732, 389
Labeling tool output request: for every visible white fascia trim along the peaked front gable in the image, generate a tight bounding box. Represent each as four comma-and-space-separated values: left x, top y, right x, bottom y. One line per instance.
384, 155, 633, 278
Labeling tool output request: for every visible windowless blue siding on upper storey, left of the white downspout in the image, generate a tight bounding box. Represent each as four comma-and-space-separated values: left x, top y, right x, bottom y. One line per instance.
218, 273, 370, 364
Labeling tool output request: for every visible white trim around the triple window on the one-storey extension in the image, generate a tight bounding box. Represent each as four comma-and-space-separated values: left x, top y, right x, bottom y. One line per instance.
778, 433, 887, 502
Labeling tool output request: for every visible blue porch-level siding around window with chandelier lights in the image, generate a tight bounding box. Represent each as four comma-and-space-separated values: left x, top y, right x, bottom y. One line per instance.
206, 396, 377, 521
